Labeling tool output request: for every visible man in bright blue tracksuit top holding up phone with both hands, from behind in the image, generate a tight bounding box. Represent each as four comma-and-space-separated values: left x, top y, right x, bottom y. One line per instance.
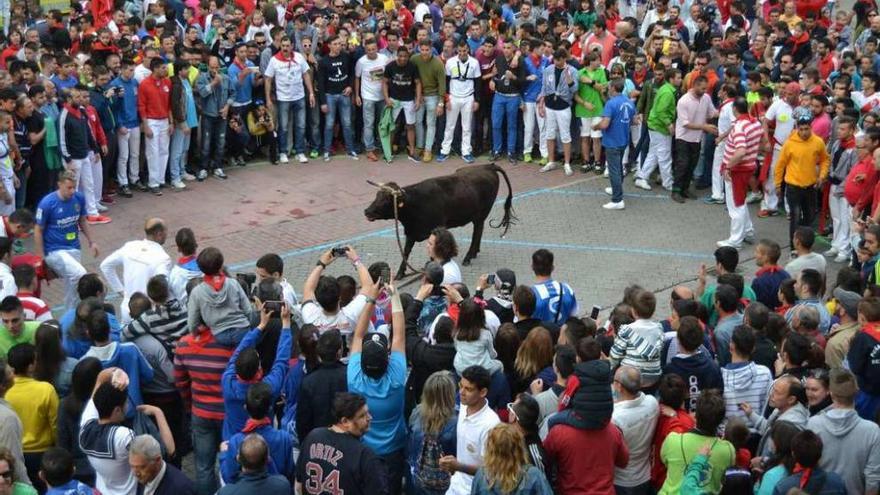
221, 305, 293, 440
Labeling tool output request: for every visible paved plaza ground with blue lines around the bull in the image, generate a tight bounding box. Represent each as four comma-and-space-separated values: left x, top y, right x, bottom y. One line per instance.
32, 154, 804, 313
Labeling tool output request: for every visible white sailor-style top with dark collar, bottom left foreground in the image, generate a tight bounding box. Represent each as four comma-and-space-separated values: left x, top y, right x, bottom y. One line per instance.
79, 400, 137, 495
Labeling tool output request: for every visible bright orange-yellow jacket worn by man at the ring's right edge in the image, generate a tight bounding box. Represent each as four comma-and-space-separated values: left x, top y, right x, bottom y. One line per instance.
773, 131, 830, 189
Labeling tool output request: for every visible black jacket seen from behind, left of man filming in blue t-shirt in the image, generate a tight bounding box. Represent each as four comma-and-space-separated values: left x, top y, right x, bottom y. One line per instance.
296, 361, 348, 439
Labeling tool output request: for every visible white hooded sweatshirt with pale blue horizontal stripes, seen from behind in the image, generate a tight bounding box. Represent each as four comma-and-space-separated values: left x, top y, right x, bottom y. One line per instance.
721, 362, 773, 432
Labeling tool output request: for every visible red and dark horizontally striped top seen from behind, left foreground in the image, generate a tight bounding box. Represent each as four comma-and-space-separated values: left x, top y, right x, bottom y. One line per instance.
174, 327, 234, 421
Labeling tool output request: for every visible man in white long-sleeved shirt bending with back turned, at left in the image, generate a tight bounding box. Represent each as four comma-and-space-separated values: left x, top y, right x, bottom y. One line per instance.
101, 218, 171, 324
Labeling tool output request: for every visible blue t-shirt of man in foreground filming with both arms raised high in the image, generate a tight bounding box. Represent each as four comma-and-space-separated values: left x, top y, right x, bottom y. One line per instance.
347, 351, 406, 455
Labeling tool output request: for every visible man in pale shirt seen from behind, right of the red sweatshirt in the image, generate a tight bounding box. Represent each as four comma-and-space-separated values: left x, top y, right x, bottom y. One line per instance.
611, 366, 660, 493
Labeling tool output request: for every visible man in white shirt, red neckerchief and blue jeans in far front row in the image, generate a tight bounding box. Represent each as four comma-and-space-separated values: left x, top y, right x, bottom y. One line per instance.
264, 36, 315, 167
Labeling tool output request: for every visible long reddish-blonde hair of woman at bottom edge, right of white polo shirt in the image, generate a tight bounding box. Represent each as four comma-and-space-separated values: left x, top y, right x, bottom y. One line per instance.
483, 423, 527, 493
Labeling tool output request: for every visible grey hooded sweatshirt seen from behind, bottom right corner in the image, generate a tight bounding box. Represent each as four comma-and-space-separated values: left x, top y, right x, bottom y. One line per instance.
807, 408, 880, 493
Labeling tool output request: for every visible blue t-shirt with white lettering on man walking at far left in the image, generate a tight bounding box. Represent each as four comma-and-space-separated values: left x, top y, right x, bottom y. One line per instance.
36, 191, 86, 254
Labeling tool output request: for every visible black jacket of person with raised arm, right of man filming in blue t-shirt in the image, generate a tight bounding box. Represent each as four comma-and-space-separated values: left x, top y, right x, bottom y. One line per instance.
404, 300, 455, 416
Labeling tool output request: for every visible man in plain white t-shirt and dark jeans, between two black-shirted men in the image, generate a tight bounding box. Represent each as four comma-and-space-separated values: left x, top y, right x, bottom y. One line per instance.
354, 38, 391, 162
